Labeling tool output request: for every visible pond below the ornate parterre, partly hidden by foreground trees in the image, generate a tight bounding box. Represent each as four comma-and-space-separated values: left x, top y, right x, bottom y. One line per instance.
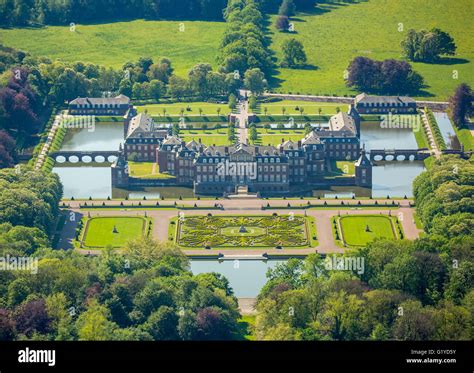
191, 259, 285, 298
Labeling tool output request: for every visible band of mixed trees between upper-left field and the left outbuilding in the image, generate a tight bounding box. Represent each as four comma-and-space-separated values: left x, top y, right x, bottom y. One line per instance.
0, 45, 246, 163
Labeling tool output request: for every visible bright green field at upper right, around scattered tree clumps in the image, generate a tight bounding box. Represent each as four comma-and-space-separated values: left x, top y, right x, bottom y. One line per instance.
270, 0, 474, 100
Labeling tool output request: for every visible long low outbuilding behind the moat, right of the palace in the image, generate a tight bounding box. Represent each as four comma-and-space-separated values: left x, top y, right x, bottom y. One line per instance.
354, 93, 416, 114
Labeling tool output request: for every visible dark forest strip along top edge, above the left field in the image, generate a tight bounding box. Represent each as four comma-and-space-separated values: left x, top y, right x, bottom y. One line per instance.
0, 0, 226, 26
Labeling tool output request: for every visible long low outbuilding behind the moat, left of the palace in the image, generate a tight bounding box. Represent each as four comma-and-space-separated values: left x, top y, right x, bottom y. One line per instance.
69, 95, 130, 116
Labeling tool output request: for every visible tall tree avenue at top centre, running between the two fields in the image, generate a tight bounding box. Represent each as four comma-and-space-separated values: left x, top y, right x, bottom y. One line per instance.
218, 0, 273, 79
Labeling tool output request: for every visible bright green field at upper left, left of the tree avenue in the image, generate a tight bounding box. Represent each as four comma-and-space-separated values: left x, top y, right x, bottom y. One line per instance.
0, 20, 226, 76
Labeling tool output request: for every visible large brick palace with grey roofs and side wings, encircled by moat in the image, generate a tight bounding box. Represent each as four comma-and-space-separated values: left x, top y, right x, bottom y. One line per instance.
112, 107, 372, 195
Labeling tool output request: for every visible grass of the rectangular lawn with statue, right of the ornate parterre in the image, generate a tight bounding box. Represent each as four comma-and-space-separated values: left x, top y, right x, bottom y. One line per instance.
339, 216, 396, 246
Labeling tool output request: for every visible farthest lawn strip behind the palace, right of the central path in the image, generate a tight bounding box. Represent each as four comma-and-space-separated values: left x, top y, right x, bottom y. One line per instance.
254, 100, 347, 116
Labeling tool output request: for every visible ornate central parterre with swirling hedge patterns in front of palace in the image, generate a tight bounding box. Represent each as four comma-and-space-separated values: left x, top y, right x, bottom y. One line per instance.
170, 214, 317, 249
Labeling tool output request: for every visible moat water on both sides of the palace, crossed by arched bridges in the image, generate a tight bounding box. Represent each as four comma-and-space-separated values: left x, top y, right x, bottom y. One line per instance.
54, 122, 423, 199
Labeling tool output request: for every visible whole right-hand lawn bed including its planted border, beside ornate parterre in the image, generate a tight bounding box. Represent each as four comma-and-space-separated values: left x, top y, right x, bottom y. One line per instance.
332, 215, 403, 246
